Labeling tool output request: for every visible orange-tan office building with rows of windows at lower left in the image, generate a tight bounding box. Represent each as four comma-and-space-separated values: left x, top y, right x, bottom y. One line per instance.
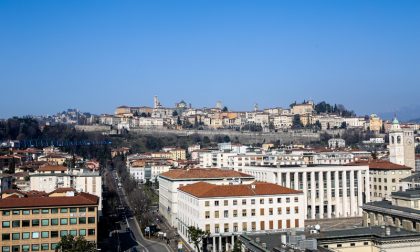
0, 192, 99, 251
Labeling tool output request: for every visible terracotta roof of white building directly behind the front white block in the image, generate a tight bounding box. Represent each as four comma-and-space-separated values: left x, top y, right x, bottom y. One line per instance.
160, 168, 253, 179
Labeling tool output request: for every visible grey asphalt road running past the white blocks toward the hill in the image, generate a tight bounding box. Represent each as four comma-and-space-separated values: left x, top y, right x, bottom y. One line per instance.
112, 170, 172, 252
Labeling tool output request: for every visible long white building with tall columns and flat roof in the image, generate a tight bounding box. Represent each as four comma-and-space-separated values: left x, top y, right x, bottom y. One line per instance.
233, 165, 370, 219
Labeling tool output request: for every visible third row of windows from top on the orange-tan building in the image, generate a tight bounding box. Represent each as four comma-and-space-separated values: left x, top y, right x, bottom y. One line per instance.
1, 229, 95, 241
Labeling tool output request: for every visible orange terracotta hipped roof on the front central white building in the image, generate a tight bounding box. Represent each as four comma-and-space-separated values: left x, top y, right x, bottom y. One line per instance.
179, 182, 302, 198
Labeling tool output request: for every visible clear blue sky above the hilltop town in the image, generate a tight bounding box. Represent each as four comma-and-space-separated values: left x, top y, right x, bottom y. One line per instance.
0, 0, 420, 118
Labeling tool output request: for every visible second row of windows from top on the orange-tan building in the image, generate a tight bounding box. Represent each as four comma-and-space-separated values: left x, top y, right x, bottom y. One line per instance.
1, 217, 96, 228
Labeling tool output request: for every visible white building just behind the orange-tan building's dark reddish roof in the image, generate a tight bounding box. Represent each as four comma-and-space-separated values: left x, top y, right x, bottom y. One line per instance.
29, 165, 102, 214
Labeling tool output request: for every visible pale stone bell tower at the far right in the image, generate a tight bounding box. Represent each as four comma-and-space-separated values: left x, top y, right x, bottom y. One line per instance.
388, 118, 416, 171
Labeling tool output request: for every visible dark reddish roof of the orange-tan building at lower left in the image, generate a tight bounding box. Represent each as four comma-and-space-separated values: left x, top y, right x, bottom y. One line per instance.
0, 193, 99, 209
